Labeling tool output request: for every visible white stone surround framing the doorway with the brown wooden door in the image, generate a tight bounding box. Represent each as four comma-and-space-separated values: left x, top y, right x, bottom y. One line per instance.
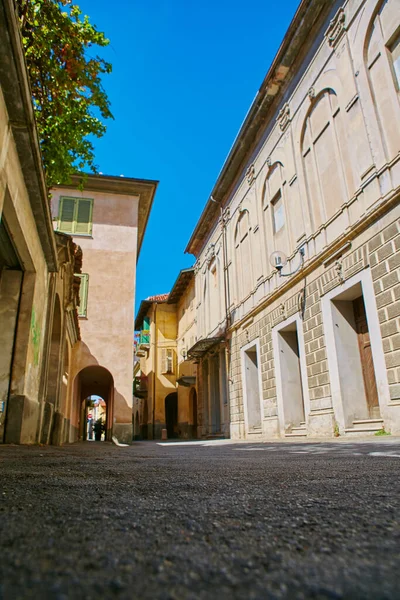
321, 268, 390, 431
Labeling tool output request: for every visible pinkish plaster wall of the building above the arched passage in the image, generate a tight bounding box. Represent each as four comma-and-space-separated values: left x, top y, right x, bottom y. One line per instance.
52, 188, 139, 441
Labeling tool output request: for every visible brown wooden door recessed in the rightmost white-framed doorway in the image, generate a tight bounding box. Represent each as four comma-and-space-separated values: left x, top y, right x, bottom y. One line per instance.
353, 296, 380, 418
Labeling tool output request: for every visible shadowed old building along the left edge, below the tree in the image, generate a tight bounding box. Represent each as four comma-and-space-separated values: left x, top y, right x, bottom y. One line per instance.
0, 0, 82, 444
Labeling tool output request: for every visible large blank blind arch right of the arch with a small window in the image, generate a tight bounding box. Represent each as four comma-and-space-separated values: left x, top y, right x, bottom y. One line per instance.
301, 90, 347, 229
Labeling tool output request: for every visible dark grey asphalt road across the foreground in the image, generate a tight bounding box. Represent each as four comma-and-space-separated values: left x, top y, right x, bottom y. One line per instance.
0, 438, 400, 600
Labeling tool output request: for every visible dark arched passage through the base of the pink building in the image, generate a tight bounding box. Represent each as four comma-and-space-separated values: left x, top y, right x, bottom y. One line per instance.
76, 365, 114, 441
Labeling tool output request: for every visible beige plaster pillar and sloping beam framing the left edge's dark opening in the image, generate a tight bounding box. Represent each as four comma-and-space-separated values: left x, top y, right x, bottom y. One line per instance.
0, 91, 48, 443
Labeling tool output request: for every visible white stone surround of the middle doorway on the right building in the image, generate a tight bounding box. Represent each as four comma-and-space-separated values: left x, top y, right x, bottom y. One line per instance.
272, 313, 311, 435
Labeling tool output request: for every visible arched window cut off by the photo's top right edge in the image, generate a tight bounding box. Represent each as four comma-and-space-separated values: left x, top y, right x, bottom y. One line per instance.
365, 0, 400, 160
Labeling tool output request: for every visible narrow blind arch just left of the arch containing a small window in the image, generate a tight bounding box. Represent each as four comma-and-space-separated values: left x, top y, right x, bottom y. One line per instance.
235, 210, 253, 301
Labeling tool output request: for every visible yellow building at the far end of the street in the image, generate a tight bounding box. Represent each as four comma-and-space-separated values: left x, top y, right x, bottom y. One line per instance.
133, 269, 199, 439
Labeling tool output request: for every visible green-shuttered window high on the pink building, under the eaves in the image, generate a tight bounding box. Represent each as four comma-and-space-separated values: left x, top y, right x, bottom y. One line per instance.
57, 197, 93, 235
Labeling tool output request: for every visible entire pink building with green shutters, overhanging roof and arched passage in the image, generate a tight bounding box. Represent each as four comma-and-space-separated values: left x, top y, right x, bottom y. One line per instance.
52, 175, 157, 442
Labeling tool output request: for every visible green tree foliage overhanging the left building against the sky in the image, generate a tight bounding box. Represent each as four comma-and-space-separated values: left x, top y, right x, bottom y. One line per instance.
16, 0, 112, 188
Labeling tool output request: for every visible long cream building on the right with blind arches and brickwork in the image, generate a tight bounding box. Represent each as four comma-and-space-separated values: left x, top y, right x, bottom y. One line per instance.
186, 0, 400, 440
